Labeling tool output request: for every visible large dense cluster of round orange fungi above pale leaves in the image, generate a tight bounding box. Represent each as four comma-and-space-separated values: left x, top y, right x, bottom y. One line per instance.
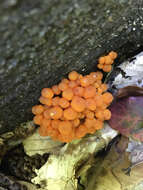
32, 53, 115, 142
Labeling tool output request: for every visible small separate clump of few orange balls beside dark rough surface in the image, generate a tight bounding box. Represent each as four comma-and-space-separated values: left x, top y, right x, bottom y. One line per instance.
97, 51, 117, 72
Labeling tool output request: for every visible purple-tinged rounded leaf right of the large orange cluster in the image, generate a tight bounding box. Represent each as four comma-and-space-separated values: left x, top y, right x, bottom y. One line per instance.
109, 96, 143, 142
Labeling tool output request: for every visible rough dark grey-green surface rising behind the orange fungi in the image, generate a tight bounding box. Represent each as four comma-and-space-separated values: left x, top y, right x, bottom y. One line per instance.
0, 0, 143, 133
